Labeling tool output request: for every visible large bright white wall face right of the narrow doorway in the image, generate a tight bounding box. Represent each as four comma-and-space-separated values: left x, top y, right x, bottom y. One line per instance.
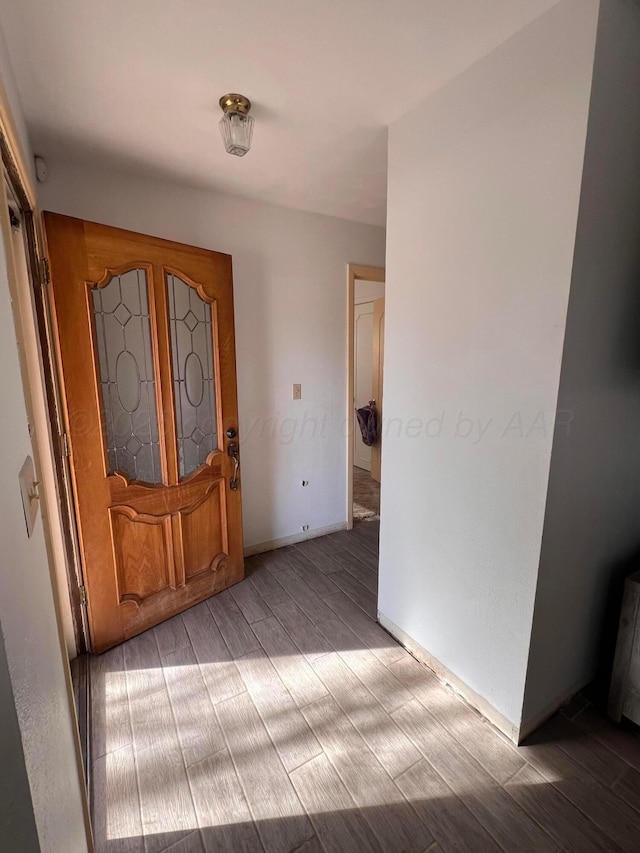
379, 0, 598, 732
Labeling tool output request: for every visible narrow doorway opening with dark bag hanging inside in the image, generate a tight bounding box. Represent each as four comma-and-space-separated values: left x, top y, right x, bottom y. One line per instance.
347, 264, 385, 529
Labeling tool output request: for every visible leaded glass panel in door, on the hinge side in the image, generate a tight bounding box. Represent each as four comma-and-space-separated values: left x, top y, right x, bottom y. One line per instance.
92, 269, 162, 483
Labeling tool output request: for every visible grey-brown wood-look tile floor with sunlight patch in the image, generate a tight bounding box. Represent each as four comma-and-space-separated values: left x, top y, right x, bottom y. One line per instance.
91, 523, 640, 853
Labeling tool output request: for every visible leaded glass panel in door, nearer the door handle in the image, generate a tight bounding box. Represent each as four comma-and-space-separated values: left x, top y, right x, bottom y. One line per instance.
166, 273, 218, 479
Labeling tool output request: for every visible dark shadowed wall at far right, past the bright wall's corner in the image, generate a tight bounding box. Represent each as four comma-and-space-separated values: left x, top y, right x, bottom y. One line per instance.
525, 0, 640, 719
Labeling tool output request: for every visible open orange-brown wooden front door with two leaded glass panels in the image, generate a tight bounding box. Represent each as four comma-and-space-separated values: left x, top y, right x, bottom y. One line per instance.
44, 213, 243, 652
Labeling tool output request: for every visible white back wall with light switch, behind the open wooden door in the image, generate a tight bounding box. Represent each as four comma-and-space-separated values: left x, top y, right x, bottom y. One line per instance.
39, 163, 384, 546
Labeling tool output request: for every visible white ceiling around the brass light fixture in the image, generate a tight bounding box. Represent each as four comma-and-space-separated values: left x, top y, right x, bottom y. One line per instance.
0, 0, 557, 225
